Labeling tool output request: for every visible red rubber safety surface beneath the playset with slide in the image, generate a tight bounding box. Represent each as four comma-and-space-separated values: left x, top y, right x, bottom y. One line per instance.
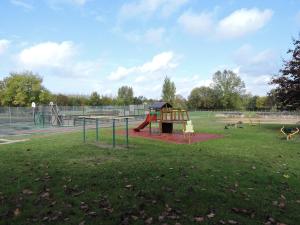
118, 129, 223, 144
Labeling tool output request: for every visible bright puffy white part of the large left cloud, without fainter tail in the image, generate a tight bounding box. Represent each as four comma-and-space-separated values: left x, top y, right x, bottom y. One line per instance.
18, 41, 75, 68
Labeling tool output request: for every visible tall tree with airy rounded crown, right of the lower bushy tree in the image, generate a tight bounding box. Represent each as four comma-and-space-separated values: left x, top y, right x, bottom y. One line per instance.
212, 70, 245, 109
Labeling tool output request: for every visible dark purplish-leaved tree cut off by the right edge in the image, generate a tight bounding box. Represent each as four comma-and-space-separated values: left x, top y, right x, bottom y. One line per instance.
271, 35, 300, 109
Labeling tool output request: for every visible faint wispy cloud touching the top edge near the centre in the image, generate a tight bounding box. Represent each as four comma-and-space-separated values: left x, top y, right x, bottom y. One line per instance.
120, 0, 188, 18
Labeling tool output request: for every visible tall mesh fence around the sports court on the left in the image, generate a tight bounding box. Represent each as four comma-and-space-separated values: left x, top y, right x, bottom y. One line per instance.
0, 105, 147, 136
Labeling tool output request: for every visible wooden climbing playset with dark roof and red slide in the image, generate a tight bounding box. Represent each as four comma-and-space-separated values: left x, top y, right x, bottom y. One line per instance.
134, 102, 190, 133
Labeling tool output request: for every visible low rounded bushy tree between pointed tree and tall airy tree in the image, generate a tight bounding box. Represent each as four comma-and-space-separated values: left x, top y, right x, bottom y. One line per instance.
188, 86, 217, 109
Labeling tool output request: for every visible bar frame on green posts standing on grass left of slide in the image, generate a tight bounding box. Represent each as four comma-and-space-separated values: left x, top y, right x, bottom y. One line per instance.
79, 116, 134, 148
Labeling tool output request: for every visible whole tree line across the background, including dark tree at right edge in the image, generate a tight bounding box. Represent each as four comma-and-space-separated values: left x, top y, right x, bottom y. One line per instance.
0, 36, 300, 110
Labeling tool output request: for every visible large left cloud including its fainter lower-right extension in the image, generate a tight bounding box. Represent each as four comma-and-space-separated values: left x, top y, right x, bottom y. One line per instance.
17, 41, 102, 78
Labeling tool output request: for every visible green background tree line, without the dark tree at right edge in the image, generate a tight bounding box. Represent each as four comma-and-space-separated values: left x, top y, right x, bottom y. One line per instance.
0, 70, 272, 110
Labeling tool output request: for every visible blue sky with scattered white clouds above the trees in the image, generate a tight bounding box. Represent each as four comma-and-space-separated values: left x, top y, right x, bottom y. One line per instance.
0, 0, 300, 98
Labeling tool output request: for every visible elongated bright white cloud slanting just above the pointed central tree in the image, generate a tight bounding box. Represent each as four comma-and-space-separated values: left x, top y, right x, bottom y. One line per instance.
108, 52, 177, 80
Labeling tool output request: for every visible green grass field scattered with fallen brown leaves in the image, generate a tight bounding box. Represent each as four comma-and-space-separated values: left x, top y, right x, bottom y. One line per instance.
0, 113, 300, 225
